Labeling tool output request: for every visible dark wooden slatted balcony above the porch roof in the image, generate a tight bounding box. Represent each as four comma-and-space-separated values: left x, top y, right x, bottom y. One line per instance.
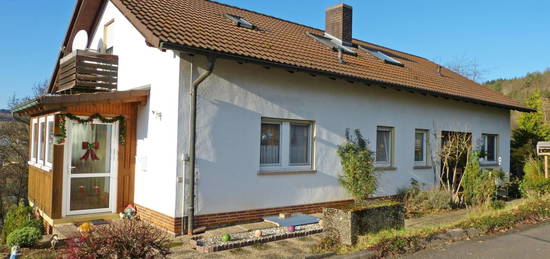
55, 50, 118, 93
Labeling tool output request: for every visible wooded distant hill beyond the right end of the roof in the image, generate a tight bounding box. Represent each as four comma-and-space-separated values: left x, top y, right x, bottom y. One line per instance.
484, 68, 550, 126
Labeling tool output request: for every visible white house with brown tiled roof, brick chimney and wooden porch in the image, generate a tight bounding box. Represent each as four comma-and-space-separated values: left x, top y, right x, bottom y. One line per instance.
14, 0, 530, 237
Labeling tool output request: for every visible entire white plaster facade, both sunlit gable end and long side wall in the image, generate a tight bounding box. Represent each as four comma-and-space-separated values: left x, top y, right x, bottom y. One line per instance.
87, 3, 510, 217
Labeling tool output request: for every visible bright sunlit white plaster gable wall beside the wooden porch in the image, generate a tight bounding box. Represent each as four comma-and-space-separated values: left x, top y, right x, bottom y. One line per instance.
90, 2, 180, 216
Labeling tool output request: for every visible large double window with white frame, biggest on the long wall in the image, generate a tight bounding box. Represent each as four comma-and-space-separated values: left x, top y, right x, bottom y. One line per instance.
260, 119, 312, 171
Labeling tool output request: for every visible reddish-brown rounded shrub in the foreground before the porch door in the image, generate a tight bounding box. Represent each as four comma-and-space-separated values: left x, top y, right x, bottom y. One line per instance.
66, 220, 170, 258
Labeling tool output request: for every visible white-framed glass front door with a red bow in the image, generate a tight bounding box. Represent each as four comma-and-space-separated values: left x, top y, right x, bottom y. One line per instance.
64, 120, 118, 215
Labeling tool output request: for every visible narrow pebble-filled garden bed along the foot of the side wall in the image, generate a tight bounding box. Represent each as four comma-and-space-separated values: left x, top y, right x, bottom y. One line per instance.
191, 224, 323, 253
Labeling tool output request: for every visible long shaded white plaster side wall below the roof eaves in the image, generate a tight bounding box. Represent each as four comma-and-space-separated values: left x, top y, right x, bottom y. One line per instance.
190, 57, 510, 214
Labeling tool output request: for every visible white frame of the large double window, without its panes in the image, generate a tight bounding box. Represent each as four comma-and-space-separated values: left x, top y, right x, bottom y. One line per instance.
259, 118, 315, 172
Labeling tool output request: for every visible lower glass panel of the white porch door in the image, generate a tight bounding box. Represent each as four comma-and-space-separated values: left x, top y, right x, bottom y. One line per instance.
70, 177, 109, 211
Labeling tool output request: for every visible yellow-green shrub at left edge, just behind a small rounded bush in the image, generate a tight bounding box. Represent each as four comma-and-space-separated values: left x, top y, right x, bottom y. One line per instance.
2, 201, 43, 244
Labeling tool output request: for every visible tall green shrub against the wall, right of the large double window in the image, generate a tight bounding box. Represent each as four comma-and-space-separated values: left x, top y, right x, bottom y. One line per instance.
337, 129, 377, 201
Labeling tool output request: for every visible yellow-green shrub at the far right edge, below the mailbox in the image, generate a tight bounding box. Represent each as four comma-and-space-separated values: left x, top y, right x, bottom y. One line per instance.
520, 157, 550, 197
